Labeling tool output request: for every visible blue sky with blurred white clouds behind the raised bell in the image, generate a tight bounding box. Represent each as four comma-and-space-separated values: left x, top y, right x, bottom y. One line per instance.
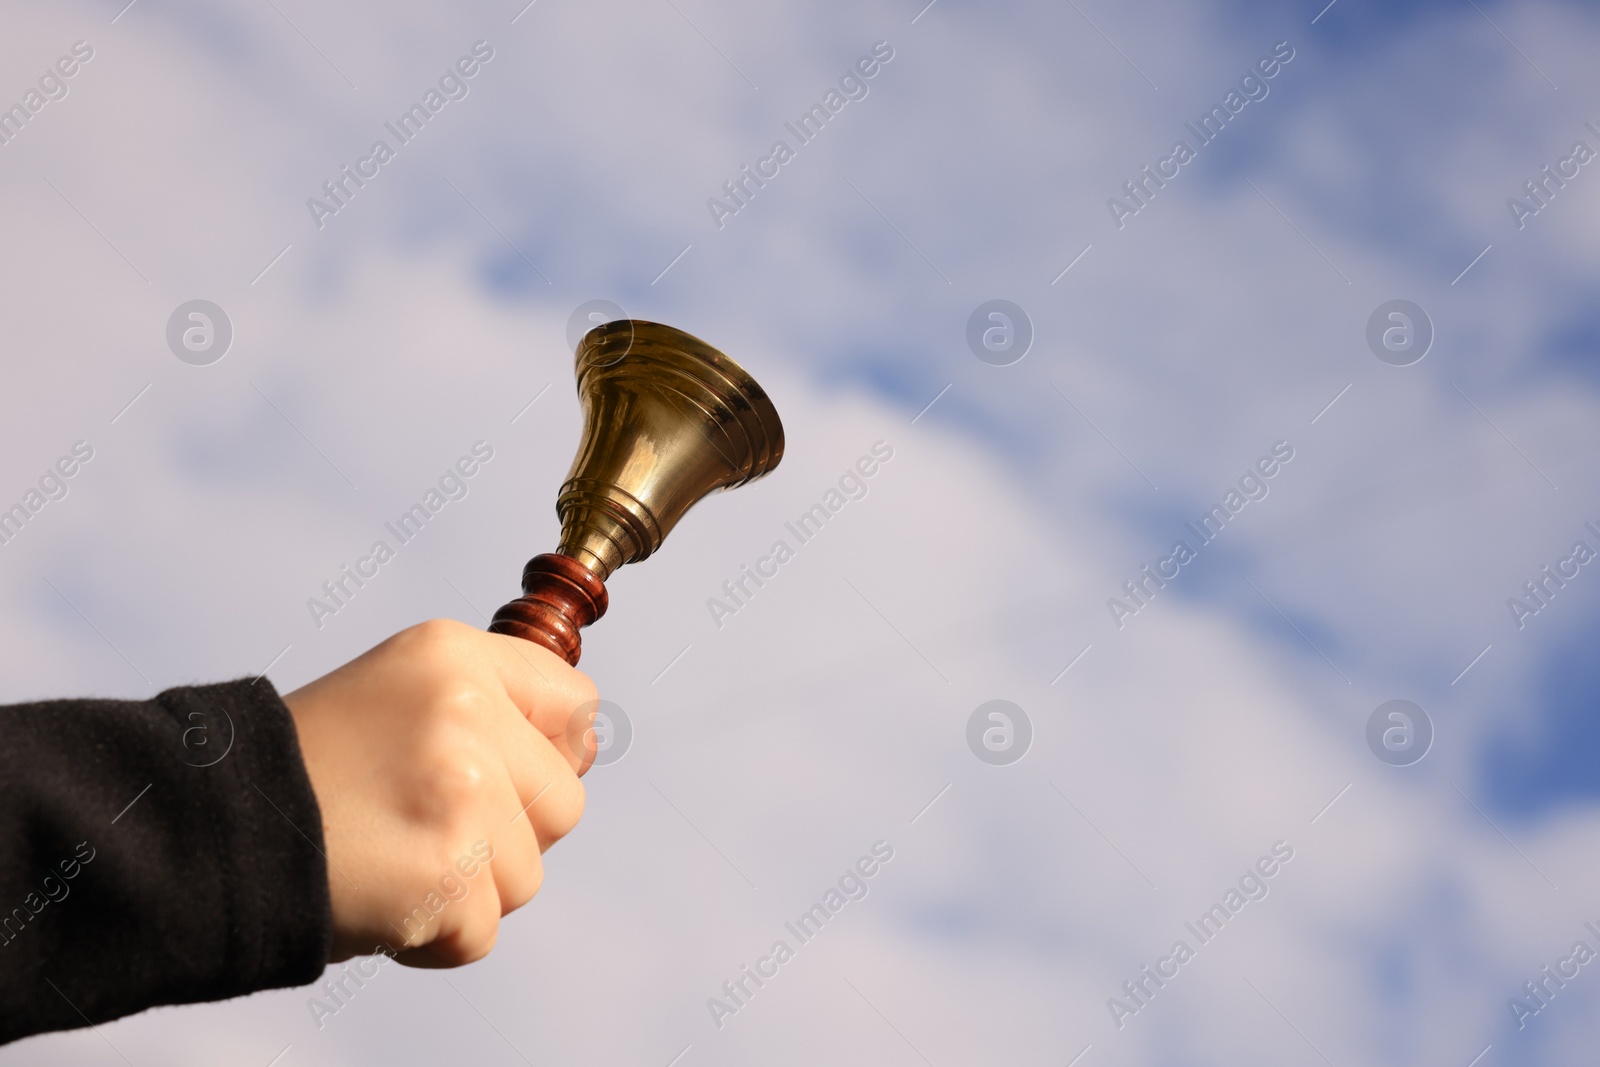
0, 0, 1600, 1067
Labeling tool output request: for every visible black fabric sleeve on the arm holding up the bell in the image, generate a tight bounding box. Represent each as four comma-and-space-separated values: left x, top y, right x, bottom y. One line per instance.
0, 678, 333, 1043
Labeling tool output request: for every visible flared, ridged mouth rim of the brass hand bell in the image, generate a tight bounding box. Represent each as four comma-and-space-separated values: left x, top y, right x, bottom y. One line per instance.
576, 318, 784, 479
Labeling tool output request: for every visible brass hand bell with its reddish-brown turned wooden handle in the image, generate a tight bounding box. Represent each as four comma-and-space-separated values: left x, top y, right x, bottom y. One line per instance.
490, 318, 784, 664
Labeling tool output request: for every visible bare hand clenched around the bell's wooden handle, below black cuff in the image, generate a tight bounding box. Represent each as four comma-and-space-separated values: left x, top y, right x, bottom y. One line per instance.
283, 619, 595, 966
